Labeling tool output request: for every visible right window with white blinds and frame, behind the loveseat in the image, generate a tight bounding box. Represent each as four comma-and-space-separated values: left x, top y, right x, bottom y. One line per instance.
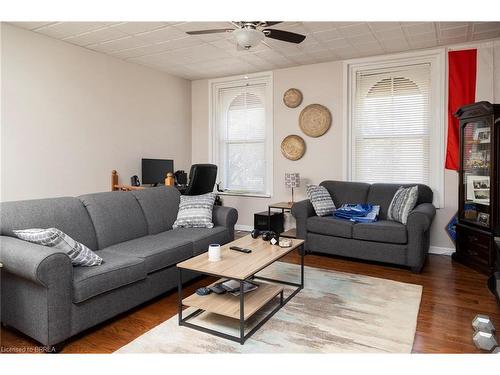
347, 50, 446, 207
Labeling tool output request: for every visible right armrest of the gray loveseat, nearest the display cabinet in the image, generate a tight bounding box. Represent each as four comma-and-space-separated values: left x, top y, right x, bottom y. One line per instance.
406, 203, 436, 272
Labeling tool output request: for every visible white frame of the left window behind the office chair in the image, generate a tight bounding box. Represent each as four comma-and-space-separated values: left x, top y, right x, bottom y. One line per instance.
208, 72, 274, 198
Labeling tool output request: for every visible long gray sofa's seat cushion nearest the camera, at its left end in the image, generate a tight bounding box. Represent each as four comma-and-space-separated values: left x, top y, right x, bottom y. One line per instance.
73, 250, 147, 303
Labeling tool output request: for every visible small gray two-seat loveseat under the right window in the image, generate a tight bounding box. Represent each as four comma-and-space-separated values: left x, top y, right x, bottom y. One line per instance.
292, 181, 436, 273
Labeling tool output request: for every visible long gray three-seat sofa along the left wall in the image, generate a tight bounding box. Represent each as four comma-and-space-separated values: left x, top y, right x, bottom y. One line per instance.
0, 187, 238, 345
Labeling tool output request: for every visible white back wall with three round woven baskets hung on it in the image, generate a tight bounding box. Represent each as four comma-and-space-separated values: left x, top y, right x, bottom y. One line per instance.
191, 39, 500, 250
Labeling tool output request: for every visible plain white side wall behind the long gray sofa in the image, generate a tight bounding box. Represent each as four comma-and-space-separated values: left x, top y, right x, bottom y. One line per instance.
1, 23, 191, 201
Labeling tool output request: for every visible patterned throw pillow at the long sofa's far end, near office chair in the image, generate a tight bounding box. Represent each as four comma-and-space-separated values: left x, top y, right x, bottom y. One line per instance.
173, 193, 215, 229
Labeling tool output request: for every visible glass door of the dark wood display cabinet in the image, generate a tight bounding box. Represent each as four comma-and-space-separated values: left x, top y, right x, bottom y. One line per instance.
461, 121, 491, 228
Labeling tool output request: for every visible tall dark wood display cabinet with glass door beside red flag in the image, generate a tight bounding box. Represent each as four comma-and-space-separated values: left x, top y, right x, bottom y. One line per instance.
453, 102, 500, 275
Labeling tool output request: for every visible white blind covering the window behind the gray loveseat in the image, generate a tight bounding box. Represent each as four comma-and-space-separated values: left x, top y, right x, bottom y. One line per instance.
351, 63, 431, 184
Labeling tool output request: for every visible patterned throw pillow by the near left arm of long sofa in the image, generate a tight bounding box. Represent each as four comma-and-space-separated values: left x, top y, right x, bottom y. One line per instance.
13, 228, 102, 267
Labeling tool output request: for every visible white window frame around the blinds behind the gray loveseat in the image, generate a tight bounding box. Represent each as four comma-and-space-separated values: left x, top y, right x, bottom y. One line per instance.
344, 49, 447, 208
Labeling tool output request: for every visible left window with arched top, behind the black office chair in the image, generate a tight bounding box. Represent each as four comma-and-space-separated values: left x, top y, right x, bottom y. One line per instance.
211, 75, 273, 196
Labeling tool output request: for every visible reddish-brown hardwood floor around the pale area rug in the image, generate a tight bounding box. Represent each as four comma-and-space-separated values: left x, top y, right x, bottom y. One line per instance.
0, 234, 500, 353
